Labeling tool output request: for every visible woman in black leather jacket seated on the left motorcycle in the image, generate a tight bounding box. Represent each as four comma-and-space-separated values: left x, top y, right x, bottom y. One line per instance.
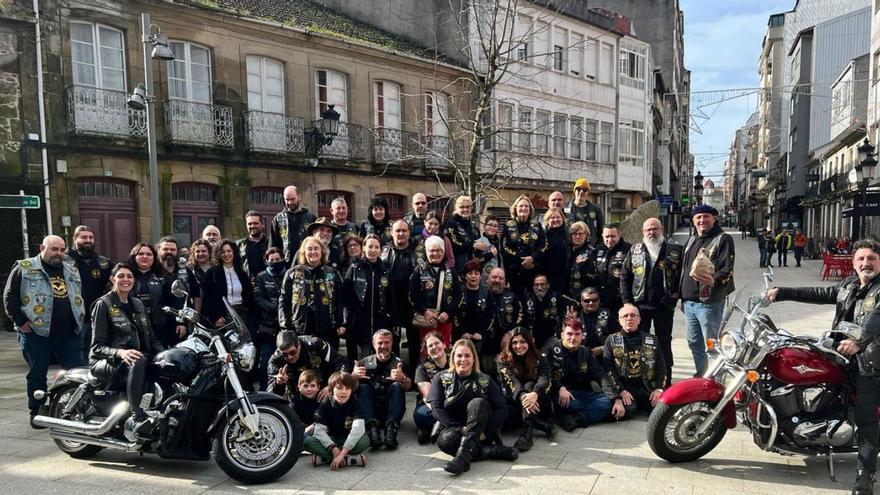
89, 264, 164, 435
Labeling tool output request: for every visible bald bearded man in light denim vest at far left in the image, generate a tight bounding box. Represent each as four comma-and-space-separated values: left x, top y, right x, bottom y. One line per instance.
3, 235, 86, 428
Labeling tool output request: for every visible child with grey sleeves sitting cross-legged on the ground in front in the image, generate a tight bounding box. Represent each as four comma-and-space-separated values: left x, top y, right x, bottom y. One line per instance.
304, 371, 370, 471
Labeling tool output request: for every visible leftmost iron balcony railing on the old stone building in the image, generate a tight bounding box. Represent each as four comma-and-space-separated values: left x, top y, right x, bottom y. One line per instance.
67, 86, 147, 138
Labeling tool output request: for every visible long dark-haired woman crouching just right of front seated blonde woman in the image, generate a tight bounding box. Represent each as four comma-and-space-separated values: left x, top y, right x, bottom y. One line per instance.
497, 327, 554, 451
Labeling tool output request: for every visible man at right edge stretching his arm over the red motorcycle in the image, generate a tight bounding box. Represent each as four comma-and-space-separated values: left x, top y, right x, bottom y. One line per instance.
767, 239, 880, 495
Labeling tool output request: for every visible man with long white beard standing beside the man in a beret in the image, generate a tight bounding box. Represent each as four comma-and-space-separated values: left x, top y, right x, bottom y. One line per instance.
620, 218, 684, 387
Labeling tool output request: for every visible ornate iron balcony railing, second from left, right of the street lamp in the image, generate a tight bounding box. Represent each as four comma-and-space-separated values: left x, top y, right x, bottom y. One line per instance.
165, 100, 235, 148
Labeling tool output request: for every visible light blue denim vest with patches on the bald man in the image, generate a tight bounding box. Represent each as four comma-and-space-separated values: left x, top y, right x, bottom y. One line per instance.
18, 255, 85, 337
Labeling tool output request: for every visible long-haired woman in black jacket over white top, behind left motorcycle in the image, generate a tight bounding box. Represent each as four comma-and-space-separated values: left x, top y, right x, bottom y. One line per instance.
202, 239, 254, 330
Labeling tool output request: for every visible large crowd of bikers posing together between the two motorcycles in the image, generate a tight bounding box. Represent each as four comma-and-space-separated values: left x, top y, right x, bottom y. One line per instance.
4, 179, 734, 474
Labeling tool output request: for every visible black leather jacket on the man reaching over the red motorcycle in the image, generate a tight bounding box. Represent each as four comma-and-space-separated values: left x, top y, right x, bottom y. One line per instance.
776, 275, 880, 376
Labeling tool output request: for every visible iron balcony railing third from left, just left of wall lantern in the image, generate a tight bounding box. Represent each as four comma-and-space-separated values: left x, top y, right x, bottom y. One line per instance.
243, 111, 306, 154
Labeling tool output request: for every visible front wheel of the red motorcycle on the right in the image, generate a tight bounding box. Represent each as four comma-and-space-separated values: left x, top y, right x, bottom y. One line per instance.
648, 402, 727, 462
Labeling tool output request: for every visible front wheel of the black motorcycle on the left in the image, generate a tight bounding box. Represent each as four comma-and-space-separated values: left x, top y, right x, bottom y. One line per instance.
213, 404, 303, 484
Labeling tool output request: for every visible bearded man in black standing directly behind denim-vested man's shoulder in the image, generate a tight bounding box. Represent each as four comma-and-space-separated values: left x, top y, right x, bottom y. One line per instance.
67, 225, 113, 360
